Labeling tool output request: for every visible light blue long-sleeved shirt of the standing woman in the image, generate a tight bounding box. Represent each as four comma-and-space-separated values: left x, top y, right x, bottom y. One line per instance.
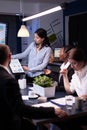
12, 42, 52, 77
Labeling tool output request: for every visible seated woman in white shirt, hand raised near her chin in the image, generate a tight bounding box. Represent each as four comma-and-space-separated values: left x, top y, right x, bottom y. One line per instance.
61, 48, 87, 98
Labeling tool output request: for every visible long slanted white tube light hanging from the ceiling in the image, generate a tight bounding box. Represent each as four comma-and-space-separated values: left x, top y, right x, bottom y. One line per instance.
22, 6, 62, 21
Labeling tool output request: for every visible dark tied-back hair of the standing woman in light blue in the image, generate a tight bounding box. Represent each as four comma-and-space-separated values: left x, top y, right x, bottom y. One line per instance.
35, 28, 50, 46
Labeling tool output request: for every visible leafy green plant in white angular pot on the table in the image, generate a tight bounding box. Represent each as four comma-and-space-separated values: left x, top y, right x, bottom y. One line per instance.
33, 75, 57, 97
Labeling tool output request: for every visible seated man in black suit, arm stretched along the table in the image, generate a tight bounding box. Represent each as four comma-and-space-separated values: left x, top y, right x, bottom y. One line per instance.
0, 44, 67, 130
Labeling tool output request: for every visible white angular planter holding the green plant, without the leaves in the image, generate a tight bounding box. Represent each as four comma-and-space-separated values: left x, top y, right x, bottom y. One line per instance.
33, 83, 56, 97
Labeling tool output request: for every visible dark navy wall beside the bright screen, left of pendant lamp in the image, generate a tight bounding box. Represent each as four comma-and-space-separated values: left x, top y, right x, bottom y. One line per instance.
0, 14, 21, 53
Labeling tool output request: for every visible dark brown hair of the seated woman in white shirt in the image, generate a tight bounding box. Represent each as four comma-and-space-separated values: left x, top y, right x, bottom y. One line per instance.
69, 48, 87, 62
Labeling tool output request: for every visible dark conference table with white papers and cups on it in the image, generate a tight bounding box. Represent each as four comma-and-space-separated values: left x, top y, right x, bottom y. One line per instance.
20, 85, 87, 130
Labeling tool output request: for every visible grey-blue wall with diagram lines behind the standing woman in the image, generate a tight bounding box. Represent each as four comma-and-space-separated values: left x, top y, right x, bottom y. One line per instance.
22, 11, 63, 65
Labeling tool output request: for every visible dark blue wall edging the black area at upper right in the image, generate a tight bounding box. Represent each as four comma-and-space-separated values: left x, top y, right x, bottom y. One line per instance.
63, 0, 87, 44
